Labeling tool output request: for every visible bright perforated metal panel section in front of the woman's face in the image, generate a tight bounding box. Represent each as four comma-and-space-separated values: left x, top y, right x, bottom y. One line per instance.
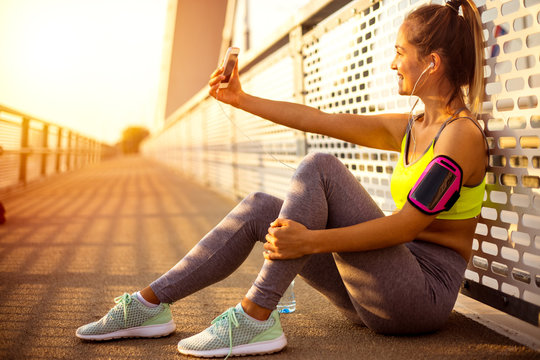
303, 1, 411, 212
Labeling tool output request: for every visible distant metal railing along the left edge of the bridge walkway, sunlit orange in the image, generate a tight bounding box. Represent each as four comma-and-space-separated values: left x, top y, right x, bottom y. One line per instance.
0, 105, 111, 191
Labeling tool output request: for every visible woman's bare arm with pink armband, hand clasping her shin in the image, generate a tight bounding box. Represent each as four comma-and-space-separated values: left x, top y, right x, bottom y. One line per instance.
264, 122, 486, 259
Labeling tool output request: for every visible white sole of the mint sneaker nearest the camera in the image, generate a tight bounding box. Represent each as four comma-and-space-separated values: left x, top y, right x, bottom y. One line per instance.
178, 334, 287, 358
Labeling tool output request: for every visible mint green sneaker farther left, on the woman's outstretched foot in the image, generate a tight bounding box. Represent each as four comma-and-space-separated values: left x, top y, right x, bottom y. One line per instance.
75, 293, 176, 341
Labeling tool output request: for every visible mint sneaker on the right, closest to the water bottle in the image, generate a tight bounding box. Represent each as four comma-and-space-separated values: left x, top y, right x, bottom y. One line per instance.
178, 304, 287, 358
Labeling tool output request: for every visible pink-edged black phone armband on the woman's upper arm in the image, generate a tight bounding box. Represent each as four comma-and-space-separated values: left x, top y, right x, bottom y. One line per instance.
407, 155, 463, 215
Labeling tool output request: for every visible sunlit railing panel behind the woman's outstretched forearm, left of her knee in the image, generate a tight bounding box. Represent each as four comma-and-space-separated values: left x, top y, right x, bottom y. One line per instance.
230, 46, 304, 198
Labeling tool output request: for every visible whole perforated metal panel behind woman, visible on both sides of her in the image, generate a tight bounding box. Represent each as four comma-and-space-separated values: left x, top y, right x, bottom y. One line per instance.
303, 0, 540, 318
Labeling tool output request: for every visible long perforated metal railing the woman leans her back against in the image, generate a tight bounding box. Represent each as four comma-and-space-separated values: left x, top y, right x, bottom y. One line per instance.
143, 0, 540, 326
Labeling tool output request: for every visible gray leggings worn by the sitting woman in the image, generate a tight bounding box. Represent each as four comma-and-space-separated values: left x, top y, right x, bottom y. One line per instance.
151, 153, 467, 334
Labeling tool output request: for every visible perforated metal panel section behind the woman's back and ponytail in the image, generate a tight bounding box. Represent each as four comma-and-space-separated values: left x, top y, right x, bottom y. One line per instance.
466, 0, 540, 312
